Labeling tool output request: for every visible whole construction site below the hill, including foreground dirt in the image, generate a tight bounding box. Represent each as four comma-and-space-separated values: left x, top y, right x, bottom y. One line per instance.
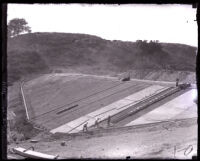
8, 73, 197, 159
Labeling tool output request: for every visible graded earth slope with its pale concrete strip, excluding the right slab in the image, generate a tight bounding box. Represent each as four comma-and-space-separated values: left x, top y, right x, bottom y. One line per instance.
24, 72, 194, 133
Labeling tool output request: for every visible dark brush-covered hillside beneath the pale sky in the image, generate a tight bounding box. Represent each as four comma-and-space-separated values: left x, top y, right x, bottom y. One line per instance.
7, 33, 196, 84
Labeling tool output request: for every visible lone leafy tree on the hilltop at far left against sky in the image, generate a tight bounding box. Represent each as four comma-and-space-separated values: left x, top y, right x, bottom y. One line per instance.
7, 18, 31, 37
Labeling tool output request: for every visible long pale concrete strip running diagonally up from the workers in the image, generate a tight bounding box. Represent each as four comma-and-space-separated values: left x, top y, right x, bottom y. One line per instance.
51, 85, 177, 133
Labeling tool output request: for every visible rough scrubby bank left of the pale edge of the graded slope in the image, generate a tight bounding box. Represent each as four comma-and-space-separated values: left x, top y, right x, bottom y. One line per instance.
7, 82, 39, 144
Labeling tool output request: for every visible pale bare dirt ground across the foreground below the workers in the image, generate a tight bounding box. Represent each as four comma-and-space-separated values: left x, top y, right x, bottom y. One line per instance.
9, 118, 197, 159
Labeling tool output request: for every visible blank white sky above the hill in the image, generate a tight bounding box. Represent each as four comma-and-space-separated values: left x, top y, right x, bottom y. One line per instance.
7, 4, 198, 47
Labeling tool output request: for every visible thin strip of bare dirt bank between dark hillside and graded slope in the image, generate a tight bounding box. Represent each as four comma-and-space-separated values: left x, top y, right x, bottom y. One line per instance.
51, 66, 196, 84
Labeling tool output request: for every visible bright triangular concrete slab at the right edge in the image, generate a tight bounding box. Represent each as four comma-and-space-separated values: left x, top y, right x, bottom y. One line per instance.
125, 89, 197, 126
